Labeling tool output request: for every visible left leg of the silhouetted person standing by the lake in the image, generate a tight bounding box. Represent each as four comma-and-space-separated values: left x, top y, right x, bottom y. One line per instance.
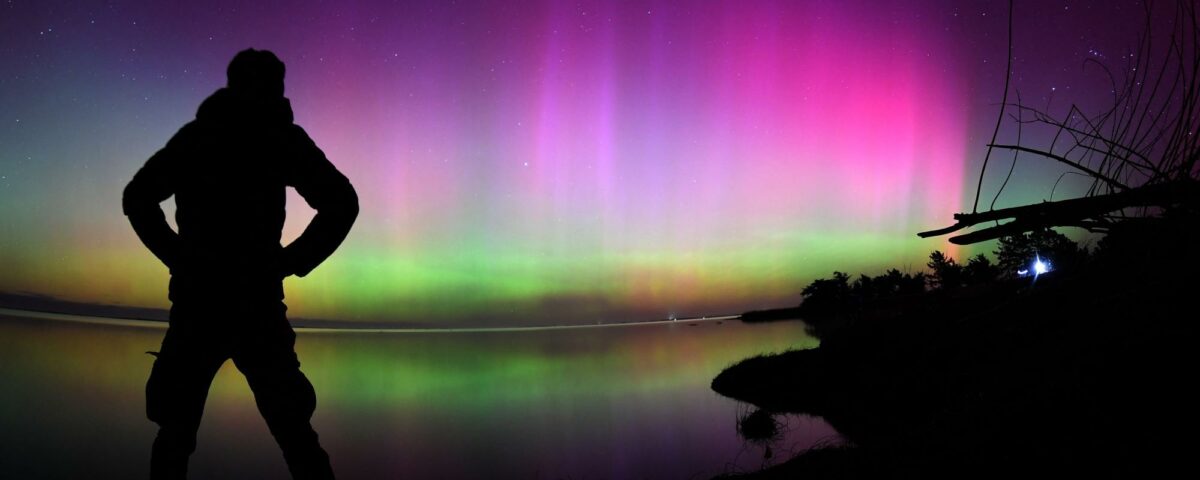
146, 308, 226, 479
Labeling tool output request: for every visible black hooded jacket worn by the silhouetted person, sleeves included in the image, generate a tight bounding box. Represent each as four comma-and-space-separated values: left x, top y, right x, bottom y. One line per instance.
122, 89, 359, 302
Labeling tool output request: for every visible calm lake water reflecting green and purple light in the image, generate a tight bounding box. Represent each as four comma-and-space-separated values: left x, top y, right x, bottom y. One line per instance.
0, 311, 836, 479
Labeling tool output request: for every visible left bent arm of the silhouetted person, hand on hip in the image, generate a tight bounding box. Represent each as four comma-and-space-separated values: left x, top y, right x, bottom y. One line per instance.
121, 127, 187, 268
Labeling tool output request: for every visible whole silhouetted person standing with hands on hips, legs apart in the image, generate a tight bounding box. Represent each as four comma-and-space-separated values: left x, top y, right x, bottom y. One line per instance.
122, 49, 359, 479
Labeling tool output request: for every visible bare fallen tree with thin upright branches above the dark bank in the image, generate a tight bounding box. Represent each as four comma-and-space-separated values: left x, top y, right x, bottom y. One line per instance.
918, 0, 1200, 245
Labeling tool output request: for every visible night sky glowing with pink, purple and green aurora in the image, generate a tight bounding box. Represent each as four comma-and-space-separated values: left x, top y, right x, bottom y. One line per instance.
0, 1, 1161, 326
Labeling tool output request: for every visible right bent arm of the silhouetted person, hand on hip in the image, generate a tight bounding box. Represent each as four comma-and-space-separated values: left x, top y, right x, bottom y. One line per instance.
282, 126, 359, 277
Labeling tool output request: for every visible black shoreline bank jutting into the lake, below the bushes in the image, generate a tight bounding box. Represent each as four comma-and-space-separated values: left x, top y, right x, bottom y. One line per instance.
713, 222, 1200, 478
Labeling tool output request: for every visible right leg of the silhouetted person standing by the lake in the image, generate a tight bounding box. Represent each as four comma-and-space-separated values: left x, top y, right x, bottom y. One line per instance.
233, 304, 334, 480
